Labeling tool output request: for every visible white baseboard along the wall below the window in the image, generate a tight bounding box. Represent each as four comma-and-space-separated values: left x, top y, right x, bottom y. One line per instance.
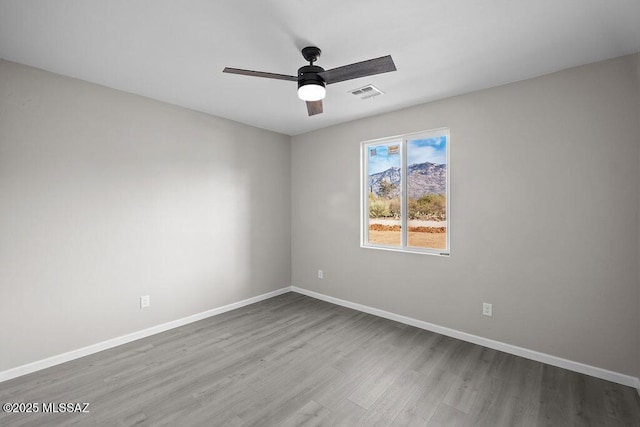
291, 286, 640, 394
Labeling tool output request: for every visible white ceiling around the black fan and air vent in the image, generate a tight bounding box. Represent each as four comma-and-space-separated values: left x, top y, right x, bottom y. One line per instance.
0, 0, 640, 135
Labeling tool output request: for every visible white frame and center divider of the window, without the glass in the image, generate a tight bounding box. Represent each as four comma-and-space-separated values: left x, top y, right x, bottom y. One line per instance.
360, 128, 451, 257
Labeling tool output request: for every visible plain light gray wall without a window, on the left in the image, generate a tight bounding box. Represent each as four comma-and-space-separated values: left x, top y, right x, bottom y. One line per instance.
0, 61, 291, 371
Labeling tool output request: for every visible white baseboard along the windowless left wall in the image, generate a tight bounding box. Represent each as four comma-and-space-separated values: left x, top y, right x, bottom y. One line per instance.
0, 286, 291, 382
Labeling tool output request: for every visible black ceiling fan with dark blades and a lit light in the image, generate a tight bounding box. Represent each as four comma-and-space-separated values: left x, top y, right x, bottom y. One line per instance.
222, 46, 396, 116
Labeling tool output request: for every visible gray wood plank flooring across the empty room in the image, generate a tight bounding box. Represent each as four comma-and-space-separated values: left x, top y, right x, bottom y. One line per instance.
0, 293, 640, 427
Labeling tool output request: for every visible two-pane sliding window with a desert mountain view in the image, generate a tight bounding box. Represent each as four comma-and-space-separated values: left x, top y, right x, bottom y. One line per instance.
361, 129, 450, 255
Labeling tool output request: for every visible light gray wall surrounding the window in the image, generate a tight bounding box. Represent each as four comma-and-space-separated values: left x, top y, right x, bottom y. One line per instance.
291, 55, 640, 376
